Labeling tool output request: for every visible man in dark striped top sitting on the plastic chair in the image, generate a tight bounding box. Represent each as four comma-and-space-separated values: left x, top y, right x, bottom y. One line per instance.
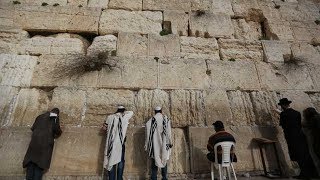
207, 121, 237, 164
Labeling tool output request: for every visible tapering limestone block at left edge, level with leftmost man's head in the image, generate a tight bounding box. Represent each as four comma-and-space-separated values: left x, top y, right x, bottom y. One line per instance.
0, 86, 19, 127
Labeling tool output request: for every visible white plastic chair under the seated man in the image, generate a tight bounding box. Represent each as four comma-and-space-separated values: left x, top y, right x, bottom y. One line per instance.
211, 141, 237, 180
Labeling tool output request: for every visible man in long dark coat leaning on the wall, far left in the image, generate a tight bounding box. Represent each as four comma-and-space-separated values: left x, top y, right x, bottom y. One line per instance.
23, 108, 62, 180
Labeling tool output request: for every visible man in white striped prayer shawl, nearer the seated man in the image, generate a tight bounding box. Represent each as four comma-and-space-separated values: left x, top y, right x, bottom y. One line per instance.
144, 107, 172, 180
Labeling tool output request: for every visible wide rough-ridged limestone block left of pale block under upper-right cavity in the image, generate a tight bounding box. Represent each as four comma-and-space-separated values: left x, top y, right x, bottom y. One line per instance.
218, 39, 262, 61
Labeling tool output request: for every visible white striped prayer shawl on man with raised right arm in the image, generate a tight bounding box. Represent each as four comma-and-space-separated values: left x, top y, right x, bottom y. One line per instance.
103, 111, 133, 171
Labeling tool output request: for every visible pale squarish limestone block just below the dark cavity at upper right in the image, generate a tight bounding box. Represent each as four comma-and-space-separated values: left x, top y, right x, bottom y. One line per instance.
262, 40, 291, 63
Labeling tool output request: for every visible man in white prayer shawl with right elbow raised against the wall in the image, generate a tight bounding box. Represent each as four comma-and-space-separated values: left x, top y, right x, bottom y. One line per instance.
103, 106, 133, 180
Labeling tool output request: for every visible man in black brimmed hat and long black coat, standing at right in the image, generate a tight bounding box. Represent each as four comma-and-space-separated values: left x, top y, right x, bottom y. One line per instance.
278, 98, 317, 179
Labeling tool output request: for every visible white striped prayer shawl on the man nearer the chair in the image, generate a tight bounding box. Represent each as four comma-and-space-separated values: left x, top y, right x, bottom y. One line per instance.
144, 113, 172, 168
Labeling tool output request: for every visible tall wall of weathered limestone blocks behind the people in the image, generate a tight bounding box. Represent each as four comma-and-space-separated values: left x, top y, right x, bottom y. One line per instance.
0, 0, 320, 179
